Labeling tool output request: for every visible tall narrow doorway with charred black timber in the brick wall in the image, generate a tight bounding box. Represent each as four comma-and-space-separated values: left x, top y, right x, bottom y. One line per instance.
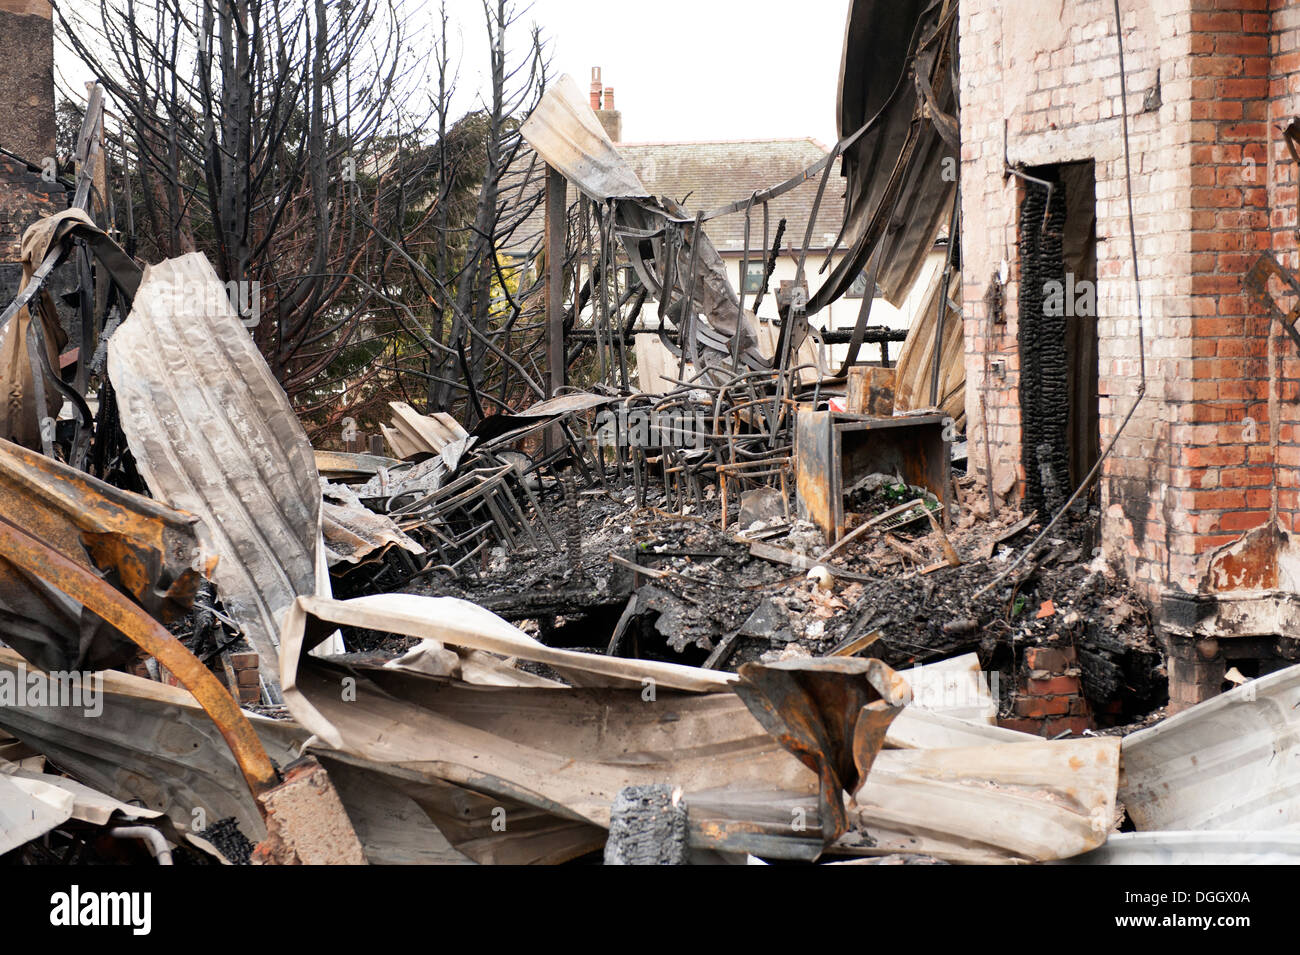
1017, 160, 1101, 513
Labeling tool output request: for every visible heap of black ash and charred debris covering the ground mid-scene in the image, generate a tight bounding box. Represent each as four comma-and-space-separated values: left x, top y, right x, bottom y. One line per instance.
387, 478, 1167, 725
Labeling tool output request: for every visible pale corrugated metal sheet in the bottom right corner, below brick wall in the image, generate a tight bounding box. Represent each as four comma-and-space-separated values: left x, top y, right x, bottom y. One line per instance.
1119, 665, 1300, 832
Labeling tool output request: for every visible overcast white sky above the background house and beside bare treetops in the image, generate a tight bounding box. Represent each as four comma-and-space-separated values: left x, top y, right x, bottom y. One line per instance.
447, 0, 849, 146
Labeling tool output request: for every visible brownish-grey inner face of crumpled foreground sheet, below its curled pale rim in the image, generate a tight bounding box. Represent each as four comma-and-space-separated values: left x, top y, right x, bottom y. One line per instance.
286, 660, 823, 861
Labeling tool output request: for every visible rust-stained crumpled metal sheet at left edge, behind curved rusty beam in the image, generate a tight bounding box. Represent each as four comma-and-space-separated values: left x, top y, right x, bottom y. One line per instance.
0, 440, 216, 672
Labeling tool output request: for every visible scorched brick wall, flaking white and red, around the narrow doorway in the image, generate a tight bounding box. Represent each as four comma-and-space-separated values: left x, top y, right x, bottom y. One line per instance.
961, 0, 1300, 605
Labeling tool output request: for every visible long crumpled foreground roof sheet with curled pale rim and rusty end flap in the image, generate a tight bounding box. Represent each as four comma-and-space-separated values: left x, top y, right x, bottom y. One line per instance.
282, 594, 905, 861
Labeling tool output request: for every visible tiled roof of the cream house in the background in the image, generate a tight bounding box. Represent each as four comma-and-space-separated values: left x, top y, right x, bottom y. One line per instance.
616, 139, 844, 252
